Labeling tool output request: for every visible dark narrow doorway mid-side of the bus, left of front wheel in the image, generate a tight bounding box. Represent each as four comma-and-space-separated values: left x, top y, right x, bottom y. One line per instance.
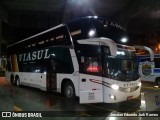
47, 60, 57, 91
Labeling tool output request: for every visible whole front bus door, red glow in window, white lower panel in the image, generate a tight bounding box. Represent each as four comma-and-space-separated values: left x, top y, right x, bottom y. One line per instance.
79, 56, 103, 103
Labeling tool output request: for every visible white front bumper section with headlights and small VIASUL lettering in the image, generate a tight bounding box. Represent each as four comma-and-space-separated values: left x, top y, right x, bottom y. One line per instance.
103, 78, 141, 103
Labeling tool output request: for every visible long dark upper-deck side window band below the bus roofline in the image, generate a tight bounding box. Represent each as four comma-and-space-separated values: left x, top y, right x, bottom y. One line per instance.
7, 26, 72, 54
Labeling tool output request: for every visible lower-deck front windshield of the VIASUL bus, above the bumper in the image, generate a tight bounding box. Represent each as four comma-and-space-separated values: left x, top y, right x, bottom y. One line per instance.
104, 51, 139, 81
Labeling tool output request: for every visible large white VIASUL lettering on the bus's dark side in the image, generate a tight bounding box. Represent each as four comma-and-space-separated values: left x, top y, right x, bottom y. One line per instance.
19, 49, 50, 62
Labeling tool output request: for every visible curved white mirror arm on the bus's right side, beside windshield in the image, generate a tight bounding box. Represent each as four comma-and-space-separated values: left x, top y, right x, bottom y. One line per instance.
134, 45, 154, 61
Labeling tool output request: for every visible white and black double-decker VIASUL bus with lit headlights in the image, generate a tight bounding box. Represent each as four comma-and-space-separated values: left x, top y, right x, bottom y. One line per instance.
6, 17, 141, 103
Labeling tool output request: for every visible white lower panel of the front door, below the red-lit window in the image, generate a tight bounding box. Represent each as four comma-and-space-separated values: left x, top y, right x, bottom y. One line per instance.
79, 74, 103, 103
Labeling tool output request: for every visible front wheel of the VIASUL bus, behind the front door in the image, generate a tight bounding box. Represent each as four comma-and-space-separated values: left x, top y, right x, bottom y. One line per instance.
64, 82, 75, 99
